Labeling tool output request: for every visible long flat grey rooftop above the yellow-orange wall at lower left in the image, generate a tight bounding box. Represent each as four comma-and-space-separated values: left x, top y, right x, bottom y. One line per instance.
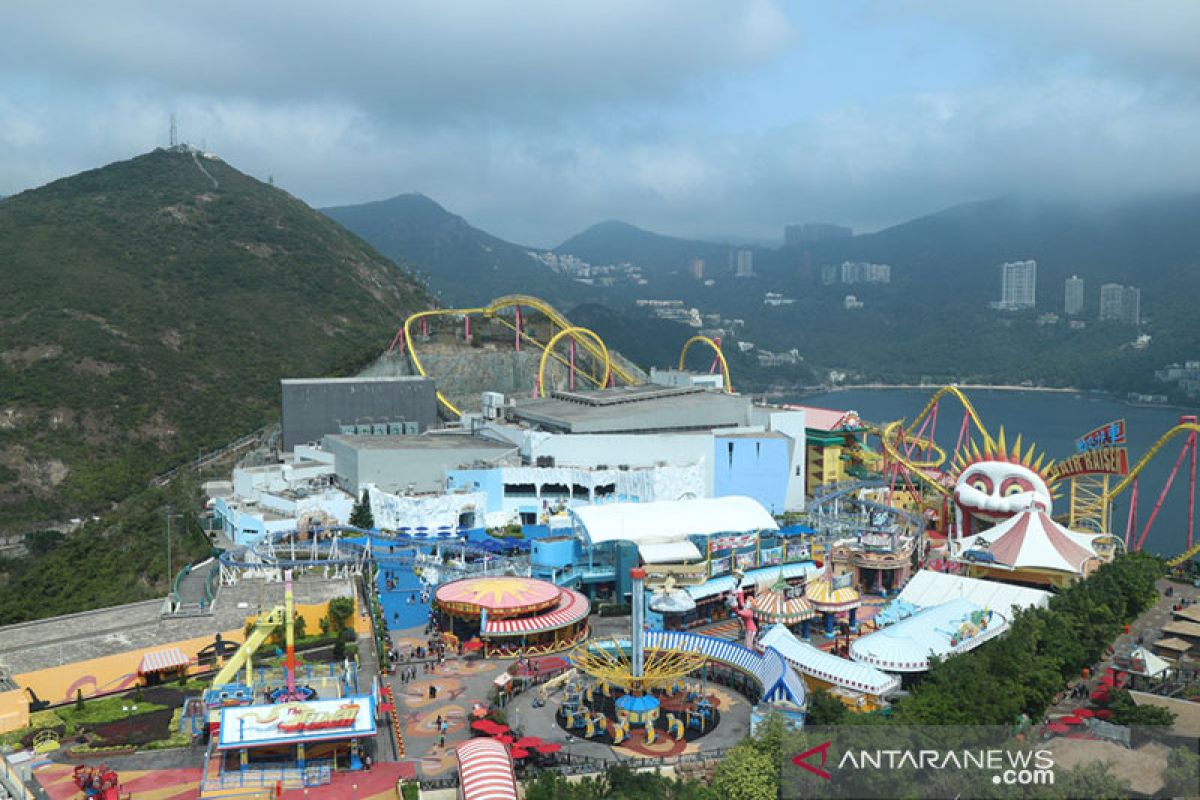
0, 577, 354, 681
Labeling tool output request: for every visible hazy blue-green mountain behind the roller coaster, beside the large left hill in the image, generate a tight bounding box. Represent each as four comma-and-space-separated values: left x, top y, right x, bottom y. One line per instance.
322, 194, 586, 306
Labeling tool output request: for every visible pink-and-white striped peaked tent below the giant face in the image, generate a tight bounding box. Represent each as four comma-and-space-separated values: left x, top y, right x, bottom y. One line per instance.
958, 510, 1099, 575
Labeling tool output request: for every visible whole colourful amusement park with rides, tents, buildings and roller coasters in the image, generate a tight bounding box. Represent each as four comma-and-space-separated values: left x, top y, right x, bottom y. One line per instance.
0, 295, 1200, 800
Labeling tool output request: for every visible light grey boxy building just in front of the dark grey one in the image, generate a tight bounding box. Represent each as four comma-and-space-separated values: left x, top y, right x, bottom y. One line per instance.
322, 433, 518, 497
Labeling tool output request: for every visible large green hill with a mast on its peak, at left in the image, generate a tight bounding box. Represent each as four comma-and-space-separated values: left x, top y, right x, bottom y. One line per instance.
0, 149, 430, 622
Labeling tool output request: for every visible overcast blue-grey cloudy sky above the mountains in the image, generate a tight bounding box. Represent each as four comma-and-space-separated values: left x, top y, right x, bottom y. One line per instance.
0, 0, 1200, 246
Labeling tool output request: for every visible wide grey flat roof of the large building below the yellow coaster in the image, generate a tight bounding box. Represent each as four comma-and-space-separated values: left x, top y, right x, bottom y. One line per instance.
509, 384, 750, 433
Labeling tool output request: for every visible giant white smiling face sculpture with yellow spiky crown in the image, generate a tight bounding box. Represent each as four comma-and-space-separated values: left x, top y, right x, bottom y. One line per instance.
954, 431, 1054, 536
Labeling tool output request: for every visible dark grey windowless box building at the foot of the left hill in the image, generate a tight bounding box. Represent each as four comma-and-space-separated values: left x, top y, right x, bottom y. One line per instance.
280, 377, 438, 450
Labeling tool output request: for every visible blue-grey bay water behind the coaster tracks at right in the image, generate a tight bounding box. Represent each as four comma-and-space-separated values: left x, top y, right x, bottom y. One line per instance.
790, 387, 1200, 555
